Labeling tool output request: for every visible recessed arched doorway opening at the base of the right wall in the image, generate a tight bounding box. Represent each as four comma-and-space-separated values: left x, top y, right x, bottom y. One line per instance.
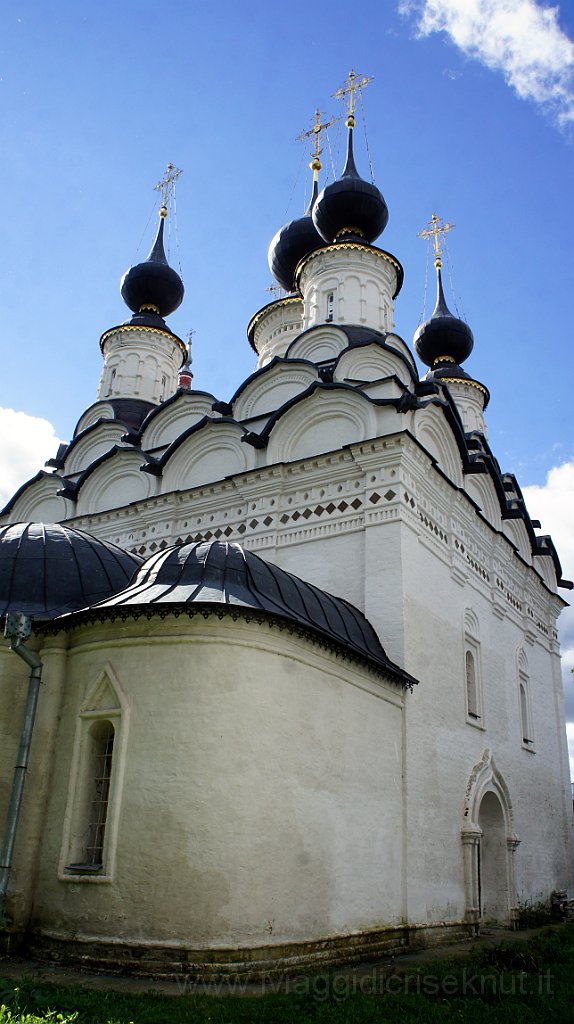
478, 791, 510, 924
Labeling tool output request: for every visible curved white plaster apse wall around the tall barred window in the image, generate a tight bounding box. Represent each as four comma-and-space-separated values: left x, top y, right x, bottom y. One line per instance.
28, 616, 403, 946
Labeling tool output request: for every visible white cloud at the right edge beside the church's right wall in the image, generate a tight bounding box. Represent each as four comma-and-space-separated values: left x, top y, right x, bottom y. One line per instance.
523, 462, 574, 778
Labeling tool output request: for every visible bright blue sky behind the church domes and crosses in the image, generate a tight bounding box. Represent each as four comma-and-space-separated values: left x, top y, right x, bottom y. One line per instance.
0, 0, 574, 745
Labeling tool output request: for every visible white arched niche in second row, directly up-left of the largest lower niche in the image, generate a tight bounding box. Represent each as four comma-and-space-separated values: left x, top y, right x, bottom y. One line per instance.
233, 359, 318, 420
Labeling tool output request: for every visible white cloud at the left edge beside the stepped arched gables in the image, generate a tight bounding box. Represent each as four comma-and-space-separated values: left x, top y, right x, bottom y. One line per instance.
0, 407, 60, 508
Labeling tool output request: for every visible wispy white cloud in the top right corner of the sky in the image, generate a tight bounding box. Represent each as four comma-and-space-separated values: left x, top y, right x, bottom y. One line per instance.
399, 0, 574, 126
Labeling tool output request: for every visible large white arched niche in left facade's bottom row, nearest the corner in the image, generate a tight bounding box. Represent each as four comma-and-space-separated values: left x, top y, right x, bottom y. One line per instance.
267, 388, 377, 464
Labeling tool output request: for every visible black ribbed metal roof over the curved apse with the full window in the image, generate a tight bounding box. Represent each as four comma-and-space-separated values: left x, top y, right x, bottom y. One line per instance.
84, 541, 415, 686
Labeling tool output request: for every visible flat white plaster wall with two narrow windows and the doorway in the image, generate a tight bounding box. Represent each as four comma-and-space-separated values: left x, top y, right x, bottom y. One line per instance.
401, 491, 572, 924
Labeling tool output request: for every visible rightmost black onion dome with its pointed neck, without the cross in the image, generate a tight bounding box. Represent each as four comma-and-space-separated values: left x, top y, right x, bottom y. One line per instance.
412, 267, 475, 377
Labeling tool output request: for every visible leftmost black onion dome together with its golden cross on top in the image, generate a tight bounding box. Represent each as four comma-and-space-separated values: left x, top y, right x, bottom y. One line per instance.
121, 164, 184, 327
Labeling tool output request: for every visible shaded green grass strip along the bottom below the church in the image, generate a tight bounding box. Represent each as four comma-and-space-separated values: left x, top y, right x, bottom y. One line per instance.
0, 925, 574, 1024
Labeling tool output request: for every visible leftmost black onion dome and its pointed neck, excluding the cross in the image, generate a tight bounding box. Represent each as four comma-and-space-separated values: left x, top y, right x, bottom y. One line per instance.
121, 217, 184, 317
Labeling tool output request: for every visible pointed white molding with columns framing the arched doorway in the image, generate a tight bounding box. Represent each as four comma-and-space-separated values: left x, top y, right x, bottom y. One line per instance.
460, 749, 520, 927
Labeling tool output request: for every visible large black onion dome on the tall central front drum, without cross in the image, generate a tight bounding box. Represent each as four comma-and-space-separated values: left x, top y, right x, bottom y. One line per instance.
313, 127, 389, 244
